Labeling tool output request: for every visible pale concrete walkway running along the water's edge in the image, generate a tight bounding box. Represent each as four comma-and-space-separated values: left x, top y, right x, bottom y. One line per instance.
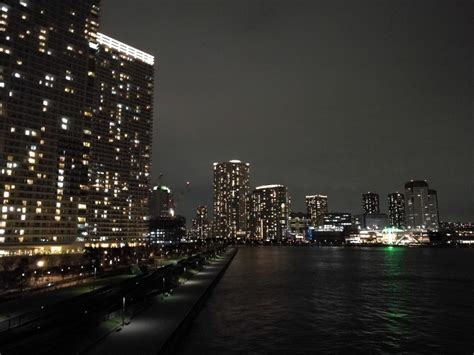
88, 248, 236, 355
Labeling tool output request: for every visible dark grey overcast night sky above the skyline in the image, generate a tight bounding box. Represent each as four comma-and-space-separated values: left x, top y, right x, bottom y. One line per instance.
101, 0, 474, 221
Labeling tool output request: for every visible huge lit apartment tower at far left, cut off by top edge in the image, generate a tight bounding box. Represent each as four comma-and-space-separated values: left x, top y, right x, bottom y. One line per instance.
0, 0, 99, 253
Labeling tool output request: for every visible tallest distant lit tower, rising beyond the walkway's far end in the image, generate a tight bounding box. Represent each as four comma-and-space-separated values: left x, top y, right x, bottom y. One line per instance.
213, 160, 250, 238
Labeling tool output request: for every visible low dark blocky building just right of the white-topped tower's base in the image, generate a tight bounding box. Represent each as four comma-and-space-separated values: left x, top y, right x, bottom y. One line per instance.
148, 216, 186, 244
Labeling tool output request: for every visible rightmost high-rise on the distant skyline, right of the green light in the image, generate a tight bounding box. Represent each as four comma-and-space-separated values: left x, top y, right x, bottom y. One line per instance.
405, 180, 439, 230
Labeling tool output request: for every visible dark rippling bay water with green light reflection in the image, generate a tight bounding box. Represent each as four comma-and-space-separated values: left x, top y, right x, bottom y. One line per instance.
179, 247, 474, 354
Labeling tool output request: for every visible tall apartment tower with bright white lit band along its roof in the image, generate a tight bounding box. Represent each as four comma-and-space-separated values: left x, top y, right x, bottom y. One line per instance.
88, 33, 154, 241
